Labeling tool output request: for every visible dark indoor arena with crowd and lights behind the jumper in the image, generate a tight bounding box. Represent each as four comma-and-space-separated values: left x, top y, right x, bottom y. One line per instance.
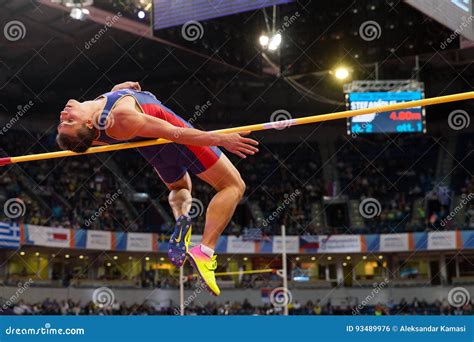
0, 0, 474, 332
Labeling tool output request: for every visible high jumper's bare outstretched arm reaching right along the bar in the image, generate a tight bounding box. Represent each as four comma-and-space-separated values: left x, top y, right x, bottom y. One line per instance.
113, 107, 258, 158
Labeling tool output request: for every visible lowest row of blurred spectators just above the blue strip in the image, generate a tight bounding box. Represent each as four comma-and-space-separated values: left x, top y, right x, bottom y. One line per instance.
0, 298, 474, 316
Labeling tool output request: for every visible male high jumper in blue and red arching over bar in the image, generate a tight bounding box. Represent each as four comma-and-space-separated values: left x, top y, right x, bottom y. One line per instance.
56, 82, 258, 296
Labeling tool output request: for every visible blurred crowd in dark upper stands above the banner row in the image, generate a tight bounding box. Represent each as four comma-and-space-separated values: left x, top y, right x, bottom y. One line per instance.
0, 133, 474, 235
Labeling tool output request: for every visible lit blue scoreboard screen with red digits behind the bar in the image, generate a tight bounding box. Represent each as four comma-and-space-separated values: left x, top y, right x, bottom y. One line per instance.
346, 91, 426, 134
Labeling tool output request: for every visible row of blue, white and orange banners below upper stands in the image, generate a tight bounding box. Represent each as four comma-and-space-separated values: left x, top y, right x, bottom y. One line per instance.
10, 222, 474, 254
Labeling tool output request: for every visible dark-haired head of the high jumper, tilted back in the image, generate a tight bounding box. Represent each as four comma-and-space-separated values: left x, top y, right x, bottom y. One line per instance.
56, 100, 96, 153
